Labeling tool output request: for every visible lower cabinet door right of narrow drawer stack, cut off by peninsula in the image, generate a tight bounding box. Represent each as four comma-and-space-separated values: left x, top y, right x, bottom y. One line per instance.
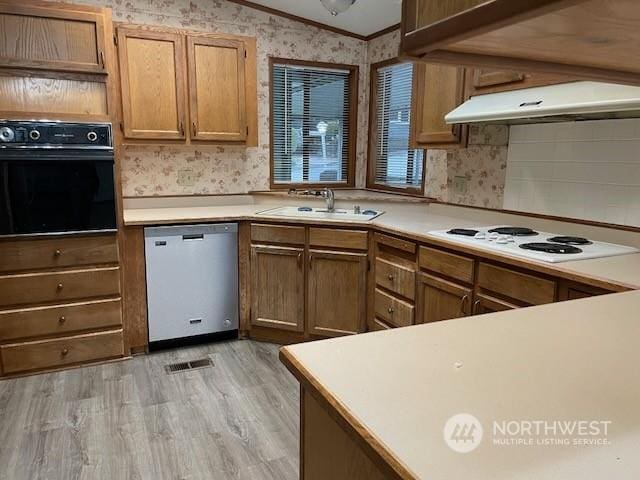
416, 273, 473, 323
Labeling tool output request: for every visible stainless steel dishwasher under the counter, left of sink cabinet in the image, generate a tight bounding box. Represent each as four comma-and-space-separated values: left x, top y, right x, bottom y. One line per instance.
144, 223, 238, 349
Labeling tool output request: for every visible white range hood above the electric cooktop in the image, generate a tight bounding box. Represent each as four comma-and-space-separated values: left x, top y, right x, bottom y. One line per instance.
445, 82, 640, 124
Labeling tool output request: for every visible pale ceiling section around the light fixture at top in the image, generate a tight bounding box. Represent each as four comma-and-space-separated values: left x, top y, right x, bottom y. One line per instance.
247, 0, 402, 37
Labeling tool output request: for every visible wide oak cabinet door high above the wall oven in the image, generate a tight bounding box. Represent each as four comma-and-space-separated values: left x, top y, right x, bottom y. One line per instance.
0, 2, 105, 73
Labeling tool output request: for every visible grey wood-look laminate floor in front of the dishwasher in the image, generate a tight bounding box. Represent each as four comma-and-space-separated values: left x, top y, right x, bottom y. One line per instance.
0, 340, 299, 480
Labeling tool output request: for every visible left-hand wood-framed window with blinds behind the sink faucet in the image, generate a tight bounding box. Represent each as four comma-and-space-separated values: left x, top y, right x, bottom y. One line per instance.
270, 58, 358, 188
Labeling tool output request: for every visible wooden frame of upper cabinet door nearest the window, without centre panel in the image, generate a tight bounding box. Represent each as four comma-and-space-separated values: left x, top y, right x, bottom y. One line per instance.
187, 35, 248, 142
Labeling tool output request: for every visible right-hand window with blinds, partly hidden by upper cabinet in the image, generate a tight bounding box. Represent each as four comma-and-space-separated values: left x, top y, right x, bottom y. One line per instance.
367, 60, 424, 194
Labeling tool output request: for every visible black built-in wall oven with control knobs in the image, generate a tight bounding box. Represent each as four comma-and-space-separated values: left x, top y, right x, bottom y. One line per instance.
0, 121, 117, 236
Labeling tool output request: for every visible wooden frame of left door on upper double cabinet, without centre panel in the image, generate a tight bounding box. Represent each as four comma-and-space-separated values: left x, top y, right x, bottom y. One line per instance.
117, 26, 186, 139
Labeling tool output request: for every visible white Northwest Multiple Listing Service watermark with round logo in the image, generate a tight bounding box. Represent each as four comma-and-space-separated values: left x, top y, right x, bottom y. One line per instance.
443, 413, 611, 453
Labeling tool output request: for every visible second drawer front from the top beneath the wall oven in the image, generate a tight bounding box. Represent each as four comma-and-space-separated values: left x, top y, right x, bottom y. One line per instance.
0, 267, 120, 307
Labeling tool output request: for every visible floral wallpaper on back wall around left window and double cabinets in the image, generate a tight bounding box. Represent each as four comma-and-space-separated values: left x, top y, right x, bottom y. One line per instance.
72, 0, 369, 196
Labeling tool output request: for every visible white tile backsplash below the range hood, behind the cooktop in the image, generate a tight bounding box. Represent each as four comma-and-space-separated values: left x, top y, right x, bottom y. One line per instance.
504, 119, 640, 227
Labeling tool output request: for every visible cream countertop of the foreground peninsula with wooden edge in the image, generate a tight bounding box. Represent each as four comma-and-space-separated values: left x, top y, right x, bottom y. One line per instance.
282, 291, 640, 480
